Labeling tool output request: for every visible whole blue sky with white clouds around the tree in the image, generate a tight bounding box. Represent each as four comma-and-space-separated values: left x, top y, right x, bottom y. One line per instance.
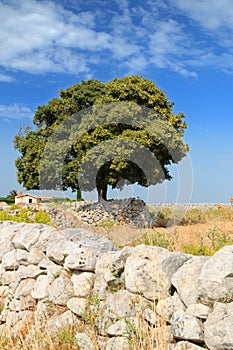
0, 0, 233, 203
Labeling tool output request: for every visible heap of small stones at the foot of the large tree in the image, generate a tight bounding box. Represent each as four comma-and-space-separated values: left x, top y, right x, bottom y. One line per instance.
75, 198, 152, 227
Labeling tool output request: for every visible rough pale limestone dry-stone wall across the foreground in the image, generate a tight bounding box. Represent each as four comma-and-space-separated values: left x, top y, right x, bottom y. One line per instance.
0, 222, 233, 350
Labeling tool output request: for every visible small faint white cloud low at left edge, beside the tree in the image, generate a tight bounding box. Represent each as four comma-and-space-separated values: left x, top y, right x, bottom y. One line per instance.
0, 104, 33, 120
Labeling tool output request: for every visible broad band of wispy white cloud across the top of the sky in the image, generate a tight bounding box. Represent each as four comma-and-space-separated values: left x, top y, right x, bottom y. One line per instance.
0, 0, 233, 78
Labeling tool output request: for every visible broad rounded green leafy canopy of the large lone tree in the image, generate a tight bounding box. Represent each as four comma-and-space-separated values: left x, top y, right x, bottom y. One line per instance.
14, 76, 188, 199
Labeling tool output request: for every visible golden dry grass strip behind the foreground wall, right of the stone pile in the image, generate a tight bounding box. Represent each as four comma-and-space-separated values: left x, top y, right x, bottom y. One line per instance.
92, 209, 233, 251
